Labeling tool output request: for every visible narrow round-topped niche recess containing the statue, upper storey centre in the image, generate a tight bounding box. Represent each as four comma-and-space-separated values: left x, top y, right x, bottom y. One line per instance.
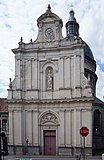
46, 67, 53, 90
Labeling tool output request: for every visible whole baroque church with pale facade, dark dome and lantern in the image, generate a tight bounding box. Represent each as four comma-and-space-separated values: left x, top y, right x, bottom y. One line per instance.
7, 5, 104, 155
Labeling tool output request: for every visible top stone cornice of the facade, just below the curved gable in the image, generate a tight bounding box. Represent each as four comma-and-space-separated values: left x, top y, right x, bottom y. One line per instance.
12, 38, 83, 54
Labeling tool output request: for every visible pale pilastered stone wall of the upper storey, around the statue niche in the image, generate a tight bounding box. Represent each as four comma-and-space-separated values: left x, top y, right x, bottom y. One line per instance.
8, 40, 92, 99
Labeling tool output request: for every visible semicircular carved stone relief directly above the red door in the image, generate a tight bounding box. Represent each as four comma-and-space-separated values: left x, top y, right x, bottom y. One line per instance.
41, 113, 58, 124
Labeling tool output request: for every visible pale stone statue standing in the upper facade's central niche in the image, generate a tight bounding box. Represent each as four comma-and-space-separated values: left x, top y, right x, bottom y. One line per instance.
47, 68, 53, 90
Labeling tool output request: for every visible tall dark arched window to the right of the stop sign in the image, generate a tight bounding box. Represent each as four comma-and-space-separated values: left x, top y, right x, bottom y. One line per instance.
94, 110, 101, 133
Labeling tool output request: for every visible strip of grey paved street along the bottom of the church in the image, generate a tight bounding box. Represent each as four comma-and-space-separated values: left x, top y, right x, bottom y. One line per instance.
4, 156, 102, 160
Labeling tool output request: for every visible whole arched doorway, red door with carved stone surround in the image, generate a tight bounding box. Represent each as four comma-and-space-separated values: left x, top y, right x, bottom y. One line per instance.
40, 111, 59, 156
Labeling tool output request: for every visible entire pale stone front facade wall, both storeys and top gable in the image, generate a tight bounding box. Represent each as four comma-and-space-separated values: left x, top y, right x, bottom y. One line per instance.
8, 6, 93, 154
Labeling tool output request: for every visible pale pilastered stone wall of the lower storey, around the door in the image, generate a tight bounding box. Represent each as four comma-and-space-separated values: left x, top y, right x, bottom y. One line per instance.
9, 103, 92, 152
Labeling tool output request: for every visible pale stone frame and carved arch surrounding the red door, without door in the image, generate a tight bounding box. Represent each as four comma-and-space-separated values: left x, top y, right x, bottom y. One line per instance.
39, 110, 60, 155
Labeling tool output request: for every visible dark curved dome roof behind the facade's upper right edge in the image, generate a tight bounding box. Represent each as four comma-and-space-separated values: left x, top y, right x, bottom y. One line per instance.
83, 41, 94, 60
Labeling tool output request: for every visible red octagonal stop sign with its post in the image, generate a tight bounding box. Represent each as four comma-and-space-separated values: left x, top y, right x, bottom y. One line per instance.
80, 127, 89, 160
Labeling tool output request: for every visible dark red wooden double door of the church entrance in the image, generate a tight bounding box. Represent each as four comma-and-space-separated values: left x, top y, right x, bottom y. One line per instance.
44, 130, 56, 156
